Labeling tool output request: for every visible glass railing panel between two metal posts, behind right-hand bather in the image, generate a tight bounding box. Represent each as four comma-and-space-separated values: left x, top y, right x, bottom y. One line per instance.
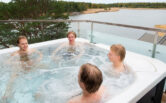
93, 32, 153, 57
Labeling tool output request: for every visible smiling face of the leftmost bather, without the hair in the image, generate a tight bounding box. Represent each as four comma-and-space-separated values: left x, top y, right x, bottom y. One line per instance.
18, 38, 28, 51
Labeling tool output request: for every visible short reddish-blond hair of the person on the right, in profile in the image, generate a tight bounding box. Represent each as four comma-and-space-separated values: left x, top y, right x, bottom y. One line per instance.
110, 44, 126, 61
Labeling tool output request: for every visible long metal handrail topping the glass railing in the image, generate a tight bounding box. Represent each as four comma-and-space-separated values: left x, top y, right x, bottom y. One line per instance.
0, 19, 166, 33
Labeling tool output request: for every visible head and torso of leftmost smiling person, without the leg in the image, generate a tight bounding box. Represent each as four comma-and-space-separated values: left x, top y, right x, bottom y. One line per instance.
9, 36, 42, 70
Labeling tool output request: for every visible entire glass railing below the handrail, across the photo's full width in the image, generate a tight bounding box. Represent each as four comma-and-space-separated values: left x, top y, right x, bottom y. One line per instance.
0, 21, 166, 62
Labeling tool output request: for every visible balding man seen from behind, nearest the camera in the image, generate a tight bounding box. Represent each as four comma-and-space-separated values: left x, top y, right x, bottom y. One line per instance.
68, 63, 106, 103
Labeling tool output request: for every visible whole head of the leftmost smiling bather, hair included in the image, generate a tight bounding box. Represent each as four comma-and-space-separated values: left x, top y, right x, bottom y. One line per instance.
17, 36, 28, 51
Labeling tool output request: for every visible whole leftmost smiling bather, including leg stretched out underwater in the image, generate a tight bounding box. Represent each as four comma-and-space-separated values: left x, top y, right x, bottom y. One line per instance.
0, 36, 42, 103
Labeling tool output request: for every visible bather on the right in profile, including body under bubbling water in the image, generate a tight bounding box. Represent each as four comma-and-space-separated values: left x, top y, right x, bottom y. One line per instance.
101, 44, 135, 95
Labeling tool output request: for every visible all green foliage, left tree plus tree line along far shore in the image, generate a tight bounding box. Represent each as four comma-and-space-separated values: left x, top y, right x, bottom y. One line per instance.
0, 0, 166, 47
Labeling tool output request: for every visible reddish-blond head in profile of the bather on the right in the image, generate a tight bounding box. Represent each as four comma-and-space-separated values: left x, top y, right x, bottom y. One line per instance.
108, 44, 126, 62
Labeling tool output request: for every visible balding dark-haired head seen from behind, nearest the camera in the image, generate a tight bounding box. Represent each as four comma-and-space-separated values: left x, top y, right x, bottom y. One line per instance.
78, 63, 103, 93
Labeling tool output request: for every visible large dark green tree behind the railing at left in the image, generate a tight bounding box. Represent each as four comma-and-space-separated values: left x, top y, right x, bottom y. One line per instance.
0, 0, 68, 47
